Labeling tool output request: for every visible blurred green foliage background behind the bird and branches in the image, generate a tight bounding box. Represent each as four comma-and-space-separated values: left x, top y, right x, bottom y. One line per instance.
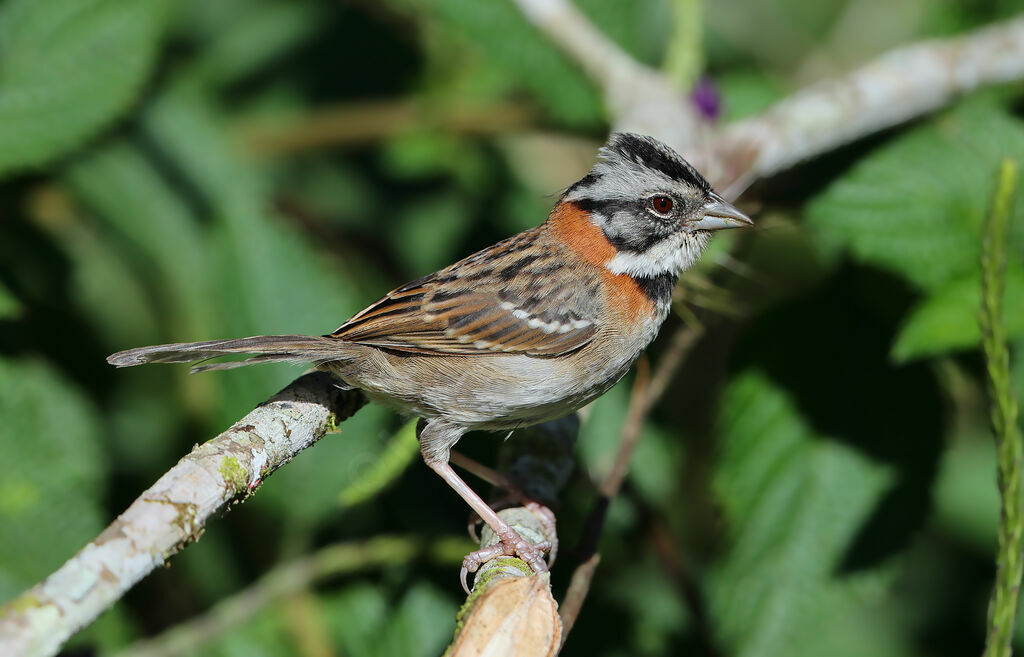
0, 0, 1024, 657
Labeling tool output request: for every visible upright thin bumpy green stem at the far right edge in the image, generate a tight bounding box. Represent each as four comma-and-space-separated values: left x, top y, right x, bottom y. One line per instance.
978, 159, 1024, 657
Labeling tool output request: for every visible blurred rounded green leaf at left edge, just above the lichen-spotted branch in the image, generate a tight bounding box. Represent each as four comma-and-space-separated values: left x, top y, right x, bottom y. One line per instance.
0, 358, 106, 601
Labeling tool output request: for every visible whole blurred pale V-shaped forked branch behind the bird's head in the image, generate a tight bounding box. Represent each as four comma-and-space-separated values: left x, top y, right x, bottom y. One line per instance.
515, 0, 1024, 194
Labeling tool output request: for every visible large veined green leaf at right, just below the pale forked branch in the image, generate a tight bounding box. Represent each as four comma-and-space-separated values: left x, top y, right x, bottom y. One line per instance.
807, 100, 1024, 291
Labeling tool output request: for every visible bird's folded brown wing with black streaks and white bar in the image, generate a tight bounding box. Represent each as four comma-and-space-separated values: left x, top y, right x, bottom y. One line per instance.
332, 230, 599, 356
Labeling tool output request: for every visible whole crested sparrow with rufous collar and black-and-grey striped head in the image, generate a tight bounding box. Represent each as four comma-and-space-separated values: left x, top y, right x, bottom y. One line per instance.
108, 132, 753, 586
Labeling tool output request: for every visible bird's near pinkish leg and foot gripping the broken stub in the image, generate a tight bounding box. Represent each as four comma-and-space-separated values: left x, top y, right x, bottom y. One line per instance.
416, 420, 550, 587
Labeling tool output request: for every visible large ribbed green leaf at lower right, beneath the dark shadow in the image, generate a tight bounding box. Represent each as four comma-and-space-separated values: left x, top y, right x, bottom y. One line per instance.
709, 373, 889, 657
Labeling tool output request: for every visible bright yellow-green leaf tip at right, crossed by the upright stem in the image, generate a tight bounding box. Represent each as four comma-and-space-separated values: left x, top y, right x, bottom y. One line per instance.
892, 268, 1024, 362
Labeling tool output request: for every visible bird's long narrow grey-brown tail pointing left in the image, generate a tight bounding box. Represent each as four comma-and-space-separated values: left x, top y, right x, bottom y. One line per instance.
106, 336, 352, 371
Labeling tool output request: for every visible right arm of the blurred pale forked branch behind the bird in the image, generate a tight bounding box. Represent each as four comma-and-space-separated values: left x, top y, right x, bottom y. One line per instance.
707, 16, 1024, 188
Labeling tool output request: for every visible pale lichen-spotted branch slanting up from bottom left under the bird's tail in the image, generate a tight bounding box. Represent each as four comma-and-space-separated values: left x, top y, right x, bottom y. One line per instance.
0, 373, 365, 655
